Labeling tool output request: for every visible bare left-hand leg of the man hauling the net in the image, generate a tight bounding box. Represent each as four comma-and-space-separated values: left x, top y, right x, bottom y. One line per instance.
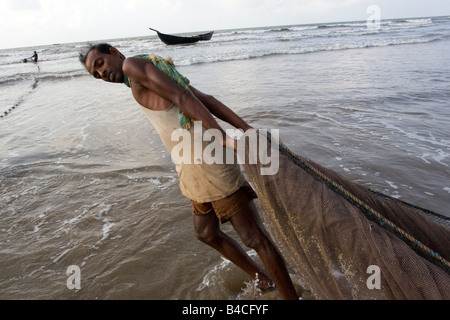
194, 211, 273, 289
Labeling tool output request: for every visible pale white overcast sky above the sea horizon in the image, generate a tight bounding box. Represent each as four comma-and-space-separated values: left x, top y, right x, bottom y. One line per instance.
0, 0, 450, 49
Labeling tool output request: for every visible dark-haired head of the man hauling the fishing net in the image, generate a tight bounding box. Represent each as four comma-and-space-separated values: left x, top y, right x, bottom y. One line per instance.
79, 43, 125, 83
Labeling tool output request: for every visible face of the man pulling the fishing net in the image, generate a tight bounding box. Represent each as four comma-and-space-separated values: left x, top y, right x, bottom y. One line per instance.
86, 48, 124, 83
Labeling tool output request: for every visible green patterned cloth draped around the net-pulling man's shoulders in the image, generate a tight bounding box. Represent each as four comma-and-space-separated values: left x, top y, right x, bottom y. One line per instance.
123, 54, 193, 130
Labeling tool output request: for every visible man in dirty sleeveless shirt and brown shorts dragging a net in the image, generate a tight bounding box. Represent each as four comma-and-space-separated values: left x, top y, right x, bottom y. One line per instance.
80, 44, 298, 300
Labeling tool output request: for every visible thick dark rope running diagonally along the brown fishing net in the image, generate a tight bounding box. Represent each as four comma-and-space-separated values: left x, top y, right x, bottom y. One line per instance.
267, 132, 450, 273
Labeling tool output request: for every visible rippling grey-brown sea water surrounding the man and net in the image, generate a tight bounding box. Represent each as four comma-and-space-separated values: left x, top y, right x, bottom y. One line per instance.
0, 16, 450, 300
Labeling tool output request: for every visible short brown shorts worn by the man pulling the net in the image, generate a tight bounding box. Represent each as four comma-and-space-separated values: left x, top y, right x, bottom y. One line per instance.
191, 182, 258, 223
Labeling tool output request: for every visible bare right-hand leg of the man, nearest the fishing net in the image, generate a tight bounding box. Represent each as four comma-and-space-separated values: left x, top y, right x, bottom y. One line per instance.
231, 201, 298, 300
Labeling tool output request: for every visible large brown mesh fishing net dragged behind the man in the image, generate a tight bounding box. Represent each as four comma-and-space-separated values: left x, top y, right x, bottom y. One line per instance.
241, 132, 450, 300
